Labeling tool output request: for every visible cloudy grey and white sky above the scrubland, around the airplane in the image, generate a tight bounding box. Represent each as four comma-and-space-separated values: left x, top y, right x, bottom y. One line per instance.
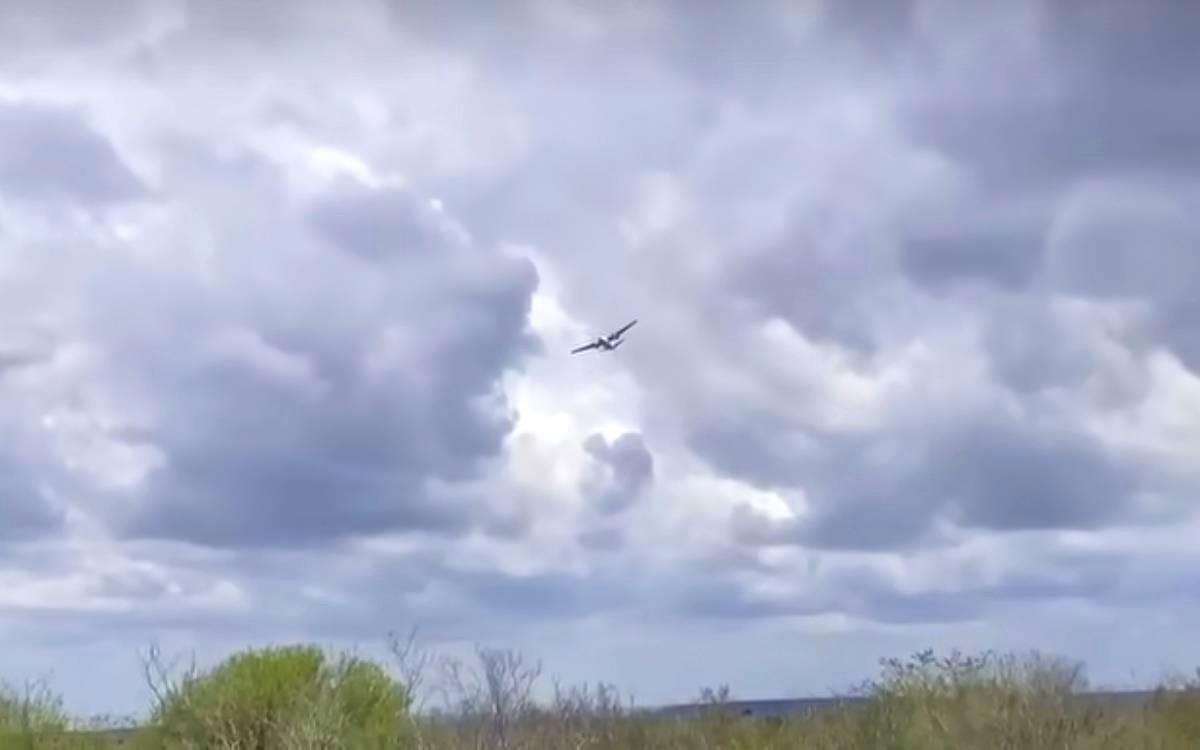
0, 0, 1200, 712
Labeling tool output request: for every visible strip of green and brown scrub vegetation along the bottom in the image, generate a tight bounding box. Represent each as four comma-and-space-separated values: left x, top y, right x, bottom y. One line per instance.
0, 644, 1200, 750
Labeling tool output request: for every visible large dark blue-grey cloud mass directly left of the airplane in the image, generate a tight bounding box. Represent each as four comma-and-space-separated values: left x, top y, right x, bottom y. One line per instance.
59, 168, 536, 546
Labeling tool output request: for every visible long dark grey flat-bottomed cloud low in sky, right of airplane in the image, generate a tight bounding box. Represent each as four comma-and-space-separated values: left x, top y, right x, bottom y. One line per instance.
732, 405, 1144, 550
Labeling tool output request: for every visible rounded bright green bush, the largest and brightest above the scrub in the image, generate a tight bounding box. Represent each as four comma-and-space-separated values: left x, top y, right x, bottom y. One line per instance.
140, 646, 413, 750
